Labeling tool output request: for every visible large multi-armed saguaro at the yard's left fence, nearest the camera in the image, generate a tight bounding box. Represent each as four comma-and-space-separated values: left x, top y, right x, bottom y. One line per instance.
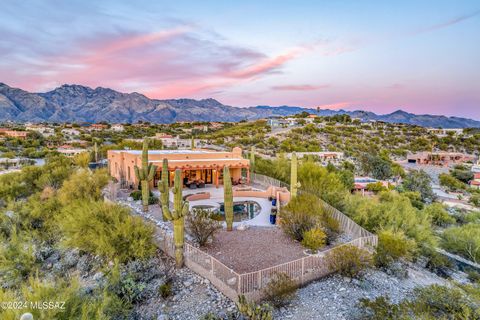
161, 170, 189, 268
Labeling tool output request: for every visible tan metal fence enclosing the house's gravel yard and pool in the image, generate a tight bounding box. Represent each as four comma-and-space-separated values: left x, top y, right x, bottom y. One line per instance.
114, 174, 378, 300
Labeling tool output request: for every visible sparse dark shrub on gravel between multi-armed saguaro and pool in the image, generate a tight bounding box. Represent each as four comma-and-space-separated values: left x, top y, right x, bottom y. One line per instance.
185, 209, 222, 247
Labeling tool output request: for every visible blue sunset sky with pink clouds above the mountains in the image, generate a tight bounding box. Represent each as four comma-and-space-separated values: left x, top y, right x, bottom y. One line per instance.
0, 0, 480, 119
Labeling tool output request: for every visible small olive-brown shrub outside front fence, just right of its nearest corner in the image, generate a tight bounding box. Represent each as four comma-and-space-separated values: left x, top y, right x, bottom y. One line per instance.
262, 273, 297, 308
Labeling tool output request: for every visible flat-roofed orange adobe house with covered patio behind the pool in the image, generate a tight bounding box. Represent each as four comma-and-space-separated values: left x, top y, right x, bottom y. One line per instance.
107, 148, 250, 188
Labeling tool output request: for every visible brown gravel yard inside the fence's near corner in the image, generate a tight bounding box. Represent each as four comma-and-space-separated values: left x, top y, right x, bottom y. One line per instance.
204, 227, 305, 273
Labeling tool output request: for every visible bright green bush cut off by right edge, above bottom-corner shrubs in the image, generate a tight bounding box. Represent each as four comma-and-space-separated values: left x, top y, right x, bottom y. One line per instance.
441, 223, 480, 263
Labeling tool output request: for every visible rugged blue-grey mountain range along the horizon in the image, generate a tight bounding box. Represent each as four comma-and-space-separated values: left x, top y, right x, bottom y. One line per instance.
0, 83, 480, 128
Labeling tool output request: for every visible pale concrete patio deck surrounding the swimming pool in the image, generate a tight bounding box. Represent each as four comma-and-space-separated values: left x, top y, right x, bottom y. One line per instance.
156, 186, 275, 228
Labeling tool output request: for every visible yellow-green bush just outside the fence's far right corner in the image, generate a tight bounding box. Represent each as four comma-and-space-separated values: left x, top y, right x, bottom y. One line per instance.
375, 230, 416, 267
